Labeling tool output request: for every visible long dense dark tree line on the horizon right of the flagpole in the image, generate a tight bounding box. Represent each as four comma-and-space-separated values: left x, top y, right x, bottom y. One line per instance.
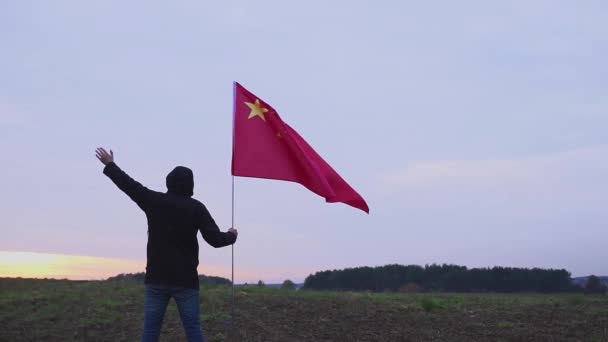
303, 264, 582, 292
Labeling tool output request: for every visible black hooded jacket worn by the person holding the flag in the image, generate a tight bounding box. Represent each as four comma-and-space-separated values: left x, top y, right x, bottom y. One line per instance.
103, 162, 236, 288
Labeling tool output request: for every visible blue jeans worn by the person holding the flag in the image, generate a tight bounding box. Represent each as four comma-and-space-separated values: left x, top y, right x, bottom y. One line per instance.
141, 285, 203, 342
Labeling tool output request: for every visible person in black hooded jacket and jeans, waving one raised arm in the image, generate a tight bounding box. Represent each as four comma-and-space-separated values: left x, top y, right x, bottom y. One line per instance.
95, 148, 238, 342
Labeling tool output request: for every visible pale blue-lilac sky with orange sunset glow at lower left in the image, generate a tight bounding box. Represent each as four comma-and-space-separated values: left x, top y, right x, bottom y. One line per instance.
0, 0, 608, 283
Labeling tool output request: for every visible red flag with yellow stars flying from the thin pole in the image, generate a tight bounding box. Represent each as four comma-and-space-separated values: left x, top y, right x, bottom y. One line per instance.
232, 82, 369, 213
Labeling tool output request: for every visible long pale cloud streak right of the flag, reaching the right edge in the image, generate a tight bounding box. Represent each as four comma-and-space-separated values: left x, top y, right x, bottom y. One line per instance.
382, 145, 608, 191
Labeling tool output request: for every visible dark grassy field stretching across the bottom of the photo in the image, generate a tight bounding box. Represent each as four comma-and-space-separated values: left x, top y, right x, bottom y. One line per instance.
0, 278, 608, 342
